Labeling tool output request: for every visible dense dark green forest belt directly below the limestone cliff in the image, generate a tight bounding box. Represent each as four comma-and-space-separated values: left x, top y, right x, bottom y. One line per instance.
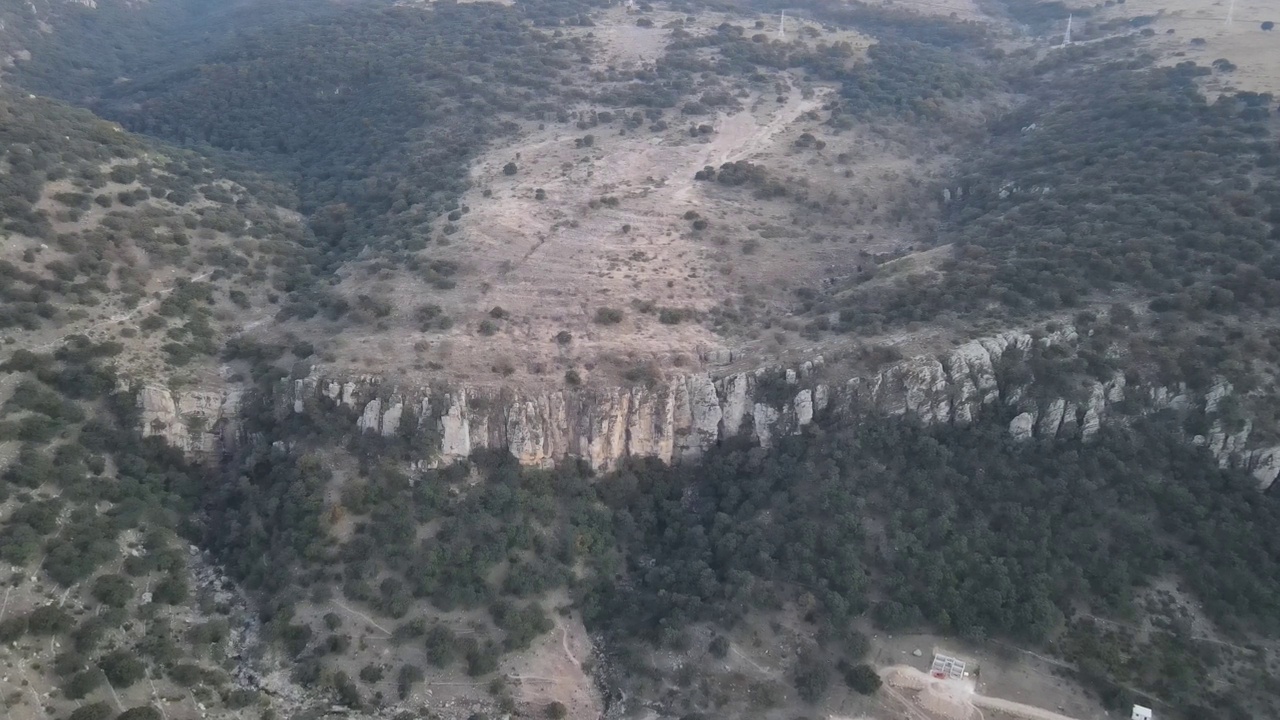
172, 363, 1280, 717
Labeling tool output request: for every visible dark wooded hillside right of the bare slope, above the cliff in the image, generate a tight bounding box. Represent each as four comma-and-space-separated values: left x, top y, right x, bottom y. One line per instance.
819, 61, 1280, 331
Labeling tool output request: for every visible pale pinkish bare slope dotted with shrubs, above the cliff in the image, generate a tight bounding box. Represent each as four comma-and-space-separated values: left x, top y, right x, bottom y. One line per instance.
317, 8, 951, 387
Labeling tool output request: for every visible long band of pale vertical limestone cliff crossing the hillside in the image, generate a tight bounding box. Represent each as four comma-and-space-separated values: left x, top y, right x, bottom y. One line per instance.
138, 328, 1280, 487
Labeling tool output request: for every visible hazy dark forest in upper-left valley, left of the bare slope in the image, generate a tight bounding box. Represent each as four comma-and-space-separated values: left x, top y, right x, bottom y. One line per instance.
17, 0, 606, 269
